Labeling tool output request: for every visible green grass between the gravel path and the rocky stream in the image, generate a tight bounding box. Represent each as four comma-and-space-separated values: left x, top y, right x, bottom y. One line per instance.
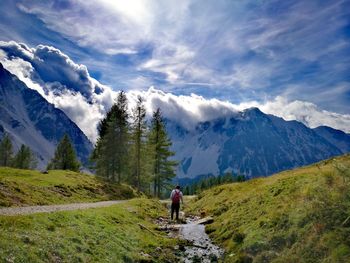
0, 198, 176, 262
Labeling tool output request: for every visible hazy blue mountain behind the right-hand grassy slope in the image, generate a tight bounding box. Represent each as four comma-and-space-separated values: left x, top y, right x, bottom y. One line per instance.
167, 108, 350, 179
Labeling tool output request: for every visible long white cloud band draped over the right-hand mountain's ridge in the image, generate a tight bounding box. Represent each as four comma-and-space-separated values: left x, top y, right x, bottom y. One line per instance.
129, 88, 350, 133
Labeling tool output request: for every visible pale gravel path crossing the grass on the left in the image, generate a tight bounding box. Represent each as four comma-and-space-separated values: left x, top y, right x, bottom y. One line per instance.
0, 200, 127, 216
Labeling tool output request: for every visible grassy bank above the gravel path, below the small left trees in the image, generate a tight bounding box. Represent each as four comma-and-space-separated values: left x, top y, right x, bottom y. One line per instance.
0, 167, 135, 207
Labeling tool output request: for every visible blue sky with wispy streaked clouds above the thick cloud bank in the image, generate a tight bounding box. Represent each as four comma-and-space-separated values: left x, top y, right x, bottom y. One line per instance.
0, 0, 350, 114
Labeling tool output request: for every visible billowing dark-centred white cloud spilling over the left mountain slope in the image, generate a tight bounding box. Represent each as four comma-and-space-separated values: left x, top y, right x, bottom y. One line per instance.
0, 41, 115, 142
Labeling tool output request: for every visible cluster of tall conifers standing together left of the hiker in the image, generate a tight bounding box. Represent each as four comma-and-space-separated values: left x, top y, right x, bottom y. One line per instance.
91, 91, 177, 197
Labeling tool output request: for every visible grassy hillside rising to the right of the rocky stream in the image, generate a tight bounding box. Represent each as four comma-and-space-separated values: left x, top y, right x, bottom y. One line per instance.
189, 155, 350, 262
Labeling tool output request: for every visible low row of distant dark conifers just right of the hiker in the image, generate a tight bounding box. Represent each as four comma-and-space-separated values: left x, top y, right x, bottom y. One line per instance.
183, 172, 246, 195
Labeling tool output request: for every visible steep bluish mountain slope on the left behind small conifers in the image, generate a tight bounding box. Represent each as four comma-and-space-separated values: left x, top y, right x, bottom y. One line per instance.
0, 63, 92, 168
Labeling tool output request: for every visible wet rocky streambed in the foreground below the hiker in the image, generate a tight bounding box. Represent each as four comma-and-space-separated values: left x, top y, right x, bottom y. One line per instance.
157, 214, 224, 263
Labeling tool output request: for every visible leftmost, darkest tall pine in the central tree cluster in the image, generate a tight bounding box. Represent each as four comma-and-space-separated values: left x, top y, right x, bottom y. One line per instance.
92, 91, 129, 183
